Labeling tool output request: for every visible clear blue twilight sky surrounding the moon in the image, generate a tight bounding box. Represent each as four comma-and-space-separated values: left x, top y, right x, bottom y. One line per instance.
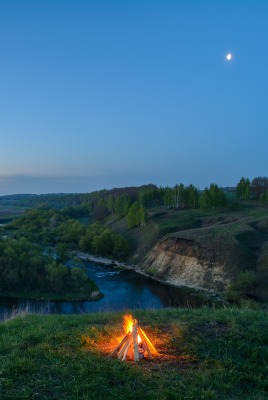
0, 0, 268, 195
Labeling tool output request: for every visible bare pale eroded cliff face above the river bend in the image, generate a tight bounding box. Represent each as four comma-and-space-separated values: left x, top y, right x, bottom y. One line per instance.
140, 237, 230, 291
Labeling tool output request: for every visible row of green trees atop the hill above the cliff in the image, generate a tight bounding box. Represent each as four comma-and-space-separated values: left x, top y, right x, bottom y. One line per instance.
92, 177, 268, 228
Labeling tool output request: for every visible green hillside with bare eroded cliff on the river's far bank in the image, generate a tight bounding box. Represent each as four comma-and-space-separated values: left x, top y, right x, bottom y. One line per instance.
105, 203, 268, 301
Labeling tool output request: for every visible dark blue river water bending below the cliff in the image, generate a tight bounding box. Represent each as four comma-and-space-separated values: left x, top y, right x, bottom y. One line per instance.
0, 262, 207, 319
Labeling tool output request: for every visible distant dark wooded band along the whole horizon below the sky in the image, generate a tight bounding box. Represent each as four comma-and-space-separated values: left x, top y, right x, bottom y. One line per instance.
0, 177, 268, 228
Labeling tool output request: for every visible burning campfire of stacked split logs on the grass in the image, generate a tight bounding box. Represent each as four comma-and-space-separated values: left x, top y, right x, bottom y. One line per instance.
110, 315, 158, 361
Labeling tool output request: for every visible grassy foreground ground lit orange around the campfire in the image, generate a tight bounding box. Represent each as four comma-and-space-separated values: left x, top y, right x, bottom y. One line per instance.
0, 309, 268, 400
